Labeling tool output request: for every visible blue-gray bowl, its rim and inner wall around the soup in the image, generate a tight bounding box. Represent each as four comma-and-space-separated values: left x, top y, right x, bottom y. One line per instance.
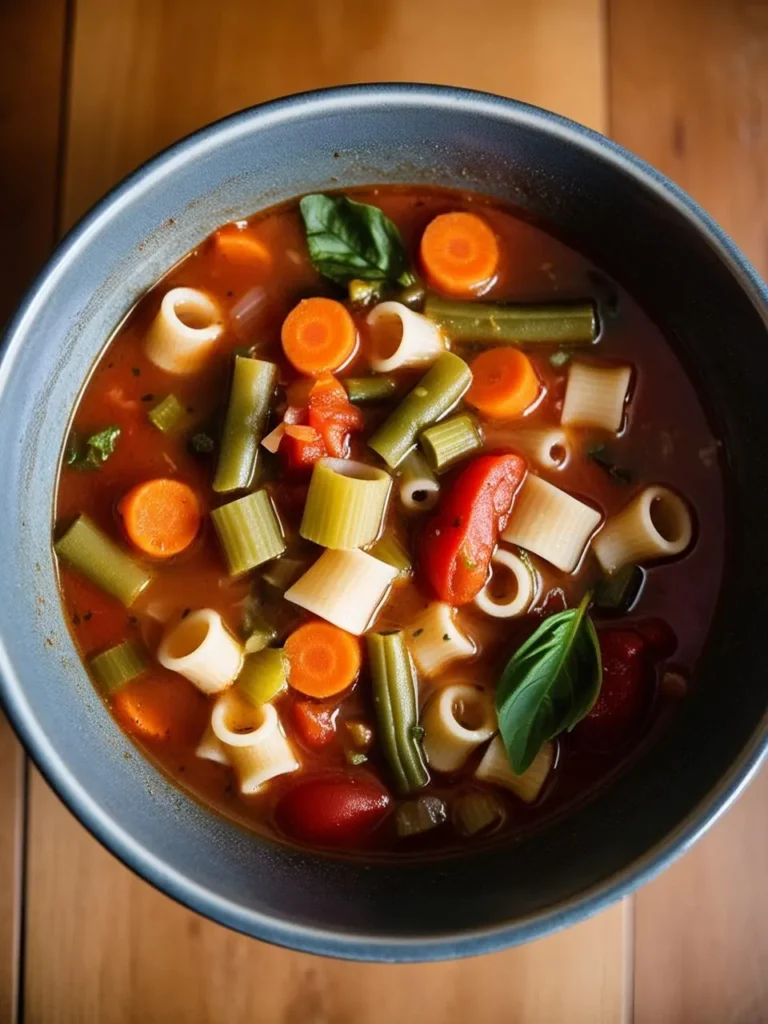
0, 85, 768, 961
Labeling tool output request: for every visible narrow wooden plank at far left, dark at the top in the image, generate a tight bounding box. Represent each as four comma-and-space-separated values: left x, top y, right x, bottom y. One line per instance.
0, 0, 65, 1021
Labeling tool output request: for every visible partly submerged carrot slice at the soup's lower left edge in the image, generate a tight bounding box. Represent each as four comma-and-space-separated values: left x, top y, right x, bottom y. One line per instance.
112, 676, 207, 742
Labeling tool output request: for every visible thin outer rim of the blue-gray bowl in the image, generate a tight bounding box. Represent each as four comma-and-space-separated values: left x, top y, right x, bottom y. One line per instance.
0, 83, 768, 963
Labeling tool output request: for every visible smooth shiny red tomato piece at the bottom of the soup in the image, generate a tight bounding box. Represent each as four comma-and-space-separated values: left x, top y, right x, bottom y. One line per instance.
275, 772, 390, 846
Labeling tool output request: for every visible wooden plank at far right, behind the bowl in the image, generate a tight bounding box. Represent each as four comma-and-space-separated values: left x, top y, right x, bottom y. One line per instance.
609, 0, 768, 1024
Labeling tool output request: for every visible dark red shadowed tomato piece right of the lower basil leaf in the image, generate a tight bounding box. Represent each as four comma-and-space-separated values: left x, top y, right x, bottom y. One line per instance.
577, 629, 653, 750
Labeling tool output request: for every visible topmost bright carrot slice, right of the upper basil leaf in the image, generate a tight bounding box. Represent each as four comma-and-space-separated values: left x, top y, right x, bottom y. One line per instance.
421, 213, 499, 298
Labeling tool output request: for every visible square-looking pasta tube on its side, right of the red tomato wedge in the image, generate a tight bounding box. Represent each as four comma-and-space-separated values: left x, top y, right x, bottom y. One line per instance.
502, 473, 601, 572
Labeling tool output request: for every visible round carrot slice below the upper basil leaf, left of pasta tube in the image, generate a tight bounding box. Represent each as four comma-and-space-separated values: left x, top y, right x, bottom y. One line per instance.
281, 297, 357, 377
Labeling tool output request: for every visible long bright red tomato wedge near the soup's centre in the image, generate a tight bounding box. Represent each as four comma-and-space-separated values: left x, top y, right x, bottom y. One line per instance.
420, 455, 525, 605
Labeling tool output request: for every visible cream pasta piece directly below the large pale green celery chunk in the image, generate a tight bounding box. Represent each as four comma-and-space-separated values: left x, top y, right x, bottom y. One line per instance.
286, 550, 397, 635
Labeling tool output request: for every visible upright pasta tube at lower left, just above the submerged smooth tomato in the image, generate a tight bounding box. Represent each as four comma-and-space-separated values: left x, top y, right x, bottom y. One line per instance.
211, 690, 299, 795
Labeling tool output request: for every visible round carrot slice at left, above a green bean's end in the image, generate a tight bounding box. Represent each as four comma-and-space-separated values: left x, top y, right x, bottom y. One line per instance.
118, 477, 201, 558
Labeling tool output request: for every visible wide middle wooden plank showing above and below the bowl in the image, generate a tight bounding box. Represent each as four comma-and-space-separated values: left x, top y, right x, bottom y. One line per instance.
26, 0, 629, 1024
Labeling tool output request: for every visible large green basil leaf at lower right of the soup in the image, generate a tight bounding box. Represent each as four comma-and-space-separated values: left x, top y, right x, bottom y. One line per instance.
496, 595, 602, 775
